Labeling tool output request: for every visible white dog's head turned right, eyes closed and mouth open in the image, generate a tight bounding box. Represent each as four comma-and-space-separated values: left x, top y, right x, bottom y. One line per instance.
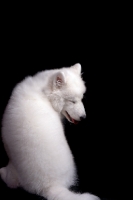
48, 64, 86, 124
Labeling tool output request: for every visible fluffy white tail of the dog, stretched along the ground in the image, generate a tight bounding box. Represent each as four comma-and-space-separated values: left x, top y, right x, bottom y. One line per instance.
46, 186, 100, 200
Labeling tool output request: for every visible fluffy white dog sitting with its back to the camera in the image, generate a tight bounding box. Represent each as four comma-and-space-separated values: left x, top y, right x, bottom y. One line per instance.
0, 64, 98, 200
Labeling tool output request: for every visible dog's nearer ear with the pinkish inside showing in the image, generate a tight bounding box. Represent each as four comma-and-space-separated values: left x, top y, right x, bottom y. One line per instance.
54, 72, 66, 88
